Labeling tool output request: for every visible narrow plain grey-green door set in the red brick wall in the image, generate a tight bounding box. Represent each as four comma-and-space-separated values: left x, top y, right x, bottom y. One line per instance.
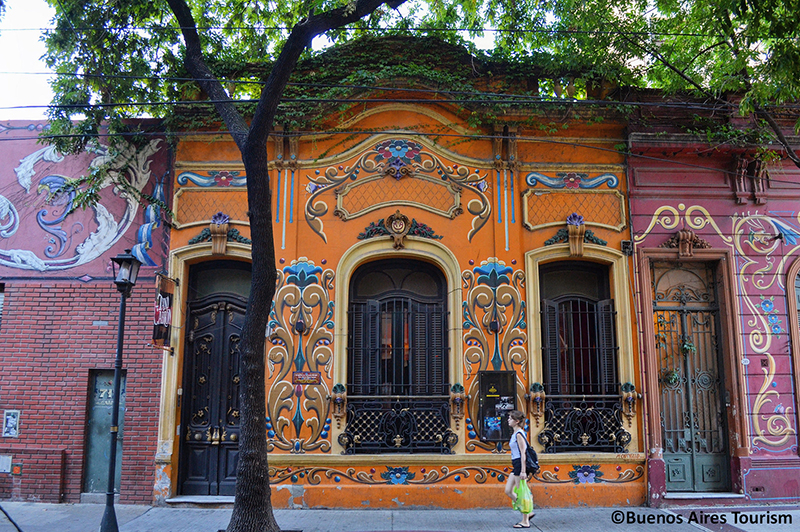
83, 370, 125, 493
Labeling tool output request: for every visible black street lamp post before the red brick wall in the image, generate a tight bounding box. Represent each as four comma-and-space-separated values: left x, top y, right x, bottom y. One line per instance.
100, 249, 142, 532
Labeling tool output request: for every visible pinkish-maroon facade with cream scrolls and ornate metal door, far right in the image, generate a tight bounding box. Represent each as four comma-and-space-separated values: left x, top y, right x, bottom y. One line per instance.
629, 107, 800, 505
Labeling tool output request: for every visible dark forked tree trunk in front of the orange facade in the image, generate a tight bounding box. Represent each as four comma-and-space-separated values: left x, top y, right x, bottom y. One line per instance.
167, 0, 405, 532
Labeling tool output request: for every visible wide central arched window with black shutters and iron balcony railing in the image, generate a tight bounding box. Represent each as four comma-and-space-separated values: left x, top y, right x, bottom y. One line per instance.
339, 259, 458, 454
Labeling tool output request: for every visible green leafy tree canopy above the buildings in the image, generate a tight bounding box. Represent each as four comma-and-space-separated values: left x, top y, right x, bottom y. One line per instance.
45, 0, 800, 163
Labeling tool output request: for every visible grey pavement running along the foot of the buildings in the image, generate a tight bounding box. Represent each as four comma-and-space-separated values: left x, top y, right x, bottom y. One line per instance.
0, 501, 800, 532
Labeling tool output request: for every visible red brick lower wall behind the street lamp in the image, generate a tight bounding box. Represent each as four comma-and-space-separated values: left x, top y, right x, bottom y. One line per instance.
0, 278, 161, 504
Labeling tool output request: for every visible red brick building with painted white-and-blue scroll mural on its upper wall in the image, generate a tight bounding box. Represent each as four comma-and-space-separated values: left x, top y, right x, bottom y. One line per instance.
0, 122, 167, 504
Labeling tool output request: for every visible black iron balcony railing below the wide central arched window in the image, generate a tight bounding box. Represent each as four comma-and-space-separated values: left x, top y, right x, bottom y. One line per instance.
339, 396, 458, 454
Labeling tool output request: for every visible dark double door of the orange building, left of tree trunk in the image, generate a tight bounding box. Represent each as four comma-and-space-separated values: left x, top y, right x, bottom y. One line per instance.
180, 294, 247, 495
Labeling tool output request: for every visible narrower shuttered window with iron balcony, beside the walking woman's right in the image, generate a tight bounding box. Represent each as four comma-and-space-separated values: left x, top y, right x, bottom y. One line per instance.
539, 261, 630, 452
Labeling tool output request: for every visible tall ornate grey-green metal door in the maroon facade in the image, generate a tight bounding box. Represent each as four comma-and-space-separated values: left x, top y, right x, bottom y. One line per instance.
652, 262, 730, 492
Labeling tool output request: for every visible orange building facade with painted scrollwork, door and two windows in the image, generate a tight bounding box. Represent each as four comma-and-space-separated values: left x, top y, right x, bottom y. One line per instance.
155, 90, 647, 508
